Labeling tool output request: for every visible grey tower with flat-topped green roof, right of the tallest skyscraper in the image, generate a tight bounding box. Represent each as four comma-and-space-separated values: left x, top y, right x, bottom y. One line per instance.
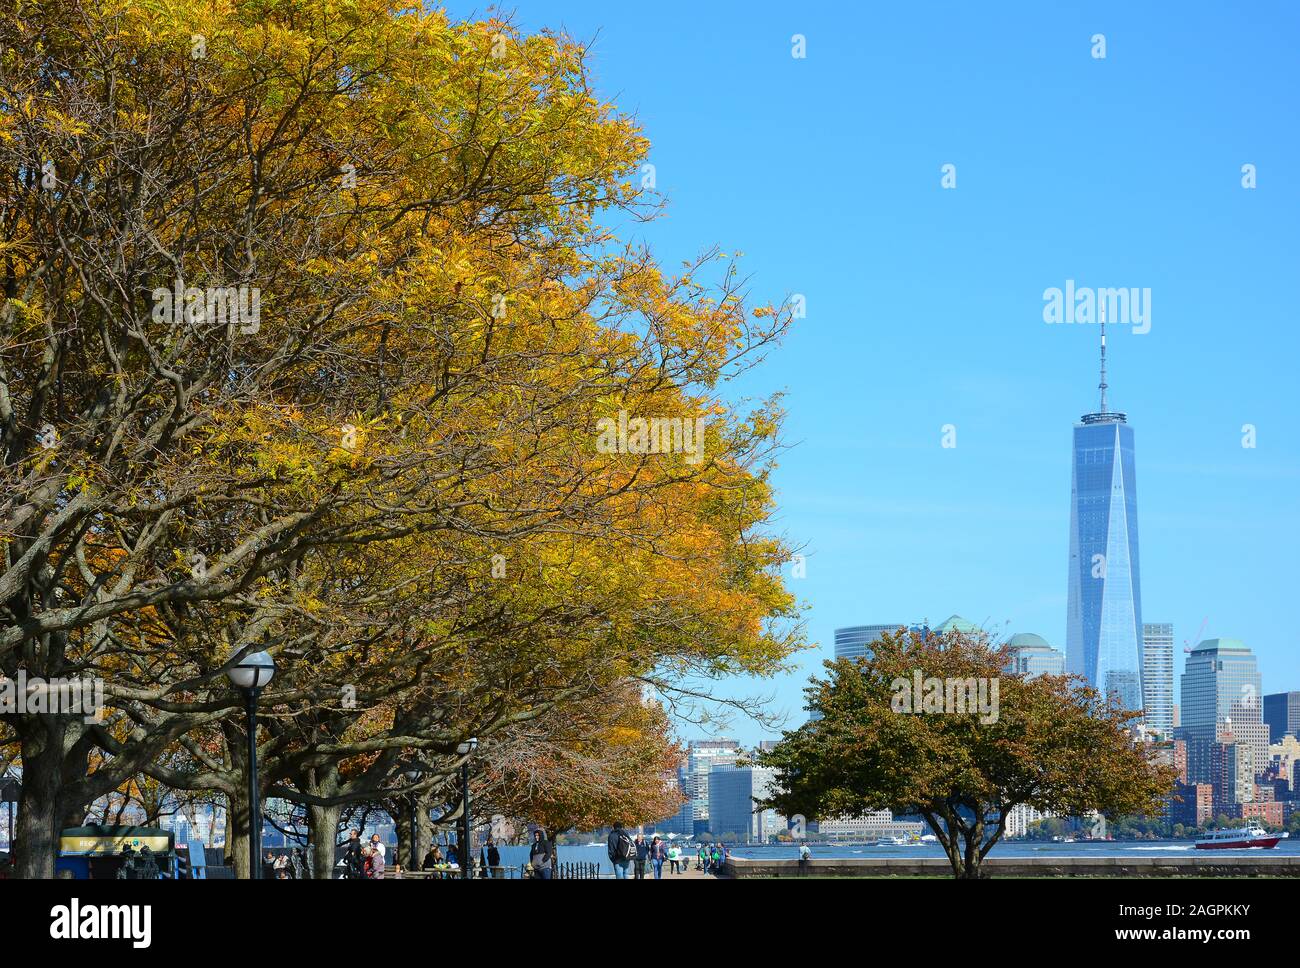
1179, 638, 1269, 802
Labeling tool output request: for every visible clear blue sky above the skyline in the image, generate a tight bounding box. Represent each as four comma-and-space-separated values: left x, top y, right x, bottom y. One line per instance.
467, 0, 1300, 742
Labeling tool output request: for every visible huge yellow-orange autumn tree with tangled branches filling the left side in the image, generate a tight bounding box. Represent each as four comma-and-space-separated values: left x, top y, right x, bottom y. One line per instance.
0, 0, 801, 877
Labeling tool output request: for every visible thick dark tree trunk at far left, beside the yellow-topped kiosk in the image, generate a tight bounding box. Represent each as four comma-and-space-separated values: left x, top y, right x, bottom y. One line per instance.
14, 716, 68, 880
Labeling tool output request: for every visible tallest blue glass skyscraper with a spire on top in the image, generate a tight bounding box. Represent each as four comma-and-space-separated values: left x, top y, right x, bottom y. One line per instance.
1066, 321, 1143, 709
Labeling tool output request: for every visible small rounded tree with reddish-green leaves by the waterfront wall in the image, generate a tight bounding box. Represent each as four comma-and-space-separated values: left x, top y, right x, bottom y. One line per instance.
763, 629, 1174, 878
